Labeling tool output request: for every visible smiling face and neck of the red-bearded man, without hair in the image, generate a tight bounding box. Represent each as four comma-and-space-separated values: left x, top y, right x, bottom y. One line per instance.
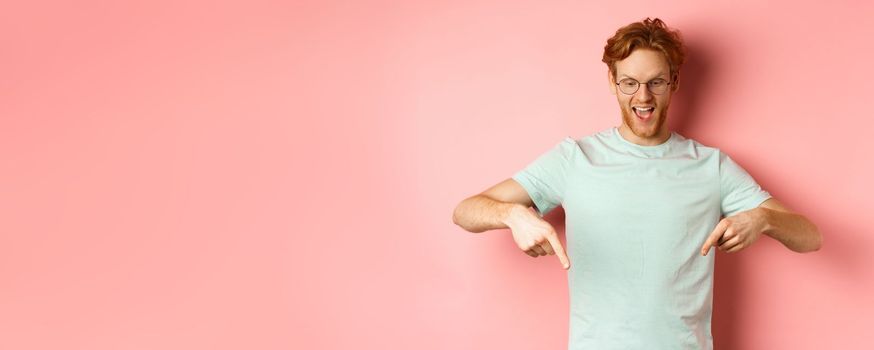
607, 49, 679, 145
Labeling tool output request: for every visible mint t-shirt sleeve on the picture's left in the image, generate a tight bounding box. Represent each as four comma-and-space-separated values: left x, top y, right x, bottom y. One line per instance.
513, 137, 581, 216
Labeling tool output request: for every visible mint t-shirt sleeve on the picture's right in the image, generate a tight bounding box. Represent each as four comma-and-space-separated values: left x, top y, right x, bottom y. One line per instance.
719, 152, 771, 217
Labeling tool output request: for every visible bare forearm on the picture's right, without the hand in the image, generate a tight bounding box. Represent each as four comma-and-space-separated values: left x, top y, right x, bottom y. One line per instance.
757, 207, 822, 253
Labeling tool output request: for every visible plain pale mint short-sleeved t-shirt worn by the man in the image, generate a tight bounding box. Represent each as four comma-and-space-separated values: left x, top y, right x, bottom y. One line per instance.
513, 127, 771, 350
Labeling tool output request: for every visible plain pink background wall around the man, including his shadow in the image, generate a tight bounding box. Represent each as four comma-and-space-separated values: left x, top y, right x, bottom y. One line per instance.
0, 1, 874, 349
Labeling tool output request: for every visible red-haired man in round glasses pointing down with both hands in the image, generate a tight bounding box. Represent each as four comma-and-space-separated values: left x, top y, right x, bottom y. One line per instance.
453, 18, 822, 349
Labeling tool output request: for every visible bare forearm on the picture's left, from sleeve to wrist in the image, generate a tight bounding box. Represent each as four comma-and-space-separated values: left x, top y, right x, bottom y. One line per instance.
452, 195, 526, 233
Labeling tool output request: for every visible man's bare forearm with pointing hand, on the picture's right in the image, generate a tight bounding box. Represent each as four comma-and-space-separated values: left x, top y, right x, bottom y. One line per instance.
701, 197, 822, 255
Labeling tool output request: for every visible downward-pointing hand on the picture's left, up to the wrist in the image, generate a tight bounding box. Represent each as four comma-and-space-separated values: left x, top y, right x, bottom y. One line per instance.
505, 205, 570, 270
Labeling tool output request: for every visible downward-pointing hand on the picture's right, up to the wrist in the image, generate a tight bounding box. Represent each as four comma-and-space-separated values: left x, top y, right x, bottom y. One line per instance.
701, 208, 765, 256
